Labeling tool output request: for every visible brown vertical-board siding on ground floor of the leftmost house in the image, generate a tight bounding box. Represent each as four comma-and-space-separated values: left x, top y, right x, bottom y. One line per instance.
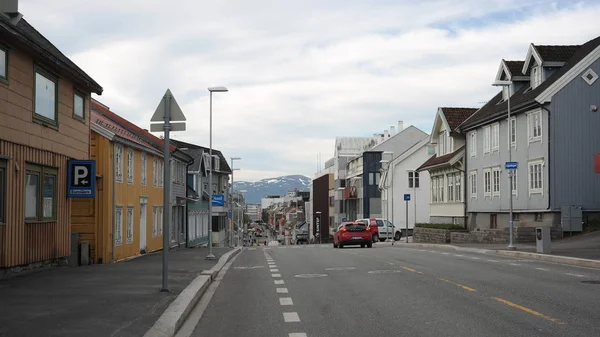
0, 139, 71, 268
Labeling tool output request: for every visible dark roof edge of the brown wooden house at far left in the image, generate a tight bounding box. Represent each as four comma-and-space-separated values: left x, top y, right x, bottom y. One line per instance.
0, 13, 102, 95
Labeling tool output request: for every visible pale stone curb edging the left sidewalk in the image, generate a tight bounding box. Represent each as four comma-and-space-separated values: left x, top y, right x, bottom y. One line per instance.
144, 247, 242, 337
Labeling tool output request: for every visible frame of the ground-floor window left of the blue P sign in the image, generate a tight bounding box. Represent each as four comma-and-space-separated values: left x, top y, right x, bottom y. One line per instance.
24, 163, 58, 223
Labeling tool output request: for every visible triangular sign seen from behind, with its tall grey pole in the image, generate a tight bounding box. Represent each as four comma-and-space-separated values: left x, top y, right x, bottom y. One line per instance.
150, 89, 186, 292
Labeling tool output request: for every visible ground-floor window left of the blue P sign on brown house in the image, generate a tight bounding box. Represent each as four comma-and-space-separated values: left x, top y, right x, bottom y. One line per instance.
25, 165, 57, 221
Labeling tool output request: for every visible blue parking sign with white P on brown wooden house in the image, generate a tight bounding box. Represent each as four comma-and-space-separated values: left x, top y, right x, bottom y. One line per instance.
67, 160, 96, 198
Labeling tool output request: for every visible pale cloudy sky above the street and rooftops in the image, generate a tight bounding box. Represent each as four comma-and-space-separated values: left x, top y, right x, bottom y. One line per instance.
19, 0, 600, 181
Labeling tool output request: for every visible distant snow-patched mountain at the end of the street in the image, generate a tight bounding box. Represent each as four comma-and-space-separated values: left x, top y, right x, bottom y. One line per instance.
233, 175, 311, 204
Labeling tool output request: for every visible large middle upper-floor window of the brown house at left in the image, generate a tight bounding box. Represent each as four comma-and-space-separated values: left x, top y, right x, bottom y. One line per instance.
33, 70, 58, 125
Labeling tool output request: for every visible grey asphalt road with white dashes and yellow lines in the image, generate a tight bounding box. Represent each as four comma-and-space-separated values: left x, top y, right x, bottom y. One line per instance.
183, 244, 600, 337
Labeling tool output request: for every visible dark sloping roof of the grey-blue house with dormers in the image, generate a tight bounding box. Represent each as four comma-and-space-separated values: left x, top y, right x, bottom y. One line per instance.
459, 37, 600, 132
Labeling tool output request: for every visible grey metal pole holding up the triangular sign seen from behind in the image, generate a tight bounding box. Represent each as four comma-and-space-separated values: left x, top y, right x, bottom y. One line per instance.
160, 95, 171, 292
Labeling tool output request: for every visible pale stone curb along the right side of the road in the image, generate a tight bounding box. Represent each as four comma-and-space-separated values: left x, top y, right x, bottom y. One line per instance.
398, 243, 600, 269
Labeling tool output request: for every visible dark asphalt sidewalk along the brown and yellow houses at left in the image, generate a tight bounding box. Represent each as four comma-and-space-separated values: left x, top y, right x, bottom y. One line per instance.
0, 244, 231, 337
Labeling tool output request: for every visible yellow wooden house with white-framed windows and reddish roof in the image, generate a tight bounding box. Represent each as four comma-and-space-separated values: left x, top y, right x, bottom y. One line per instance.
71, 100, 164, 263
